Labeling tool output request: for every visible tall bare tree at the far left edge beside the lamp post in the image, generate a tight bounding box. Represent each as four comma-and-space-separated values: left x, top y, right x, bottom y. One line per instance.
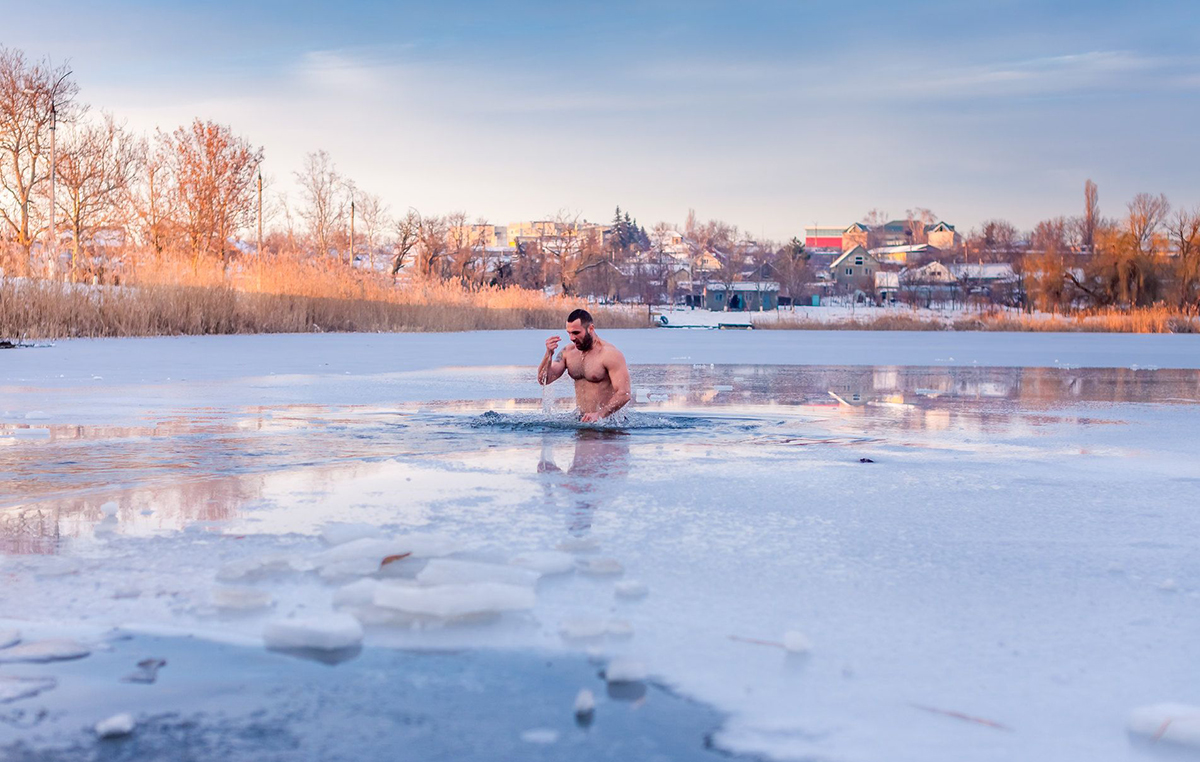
0, 48, 79, 272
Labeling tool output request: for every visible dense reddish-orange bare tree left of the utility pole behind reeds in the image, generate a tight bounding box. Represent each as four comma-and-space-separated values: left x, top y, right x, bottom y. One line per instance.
160, 119, 263, 271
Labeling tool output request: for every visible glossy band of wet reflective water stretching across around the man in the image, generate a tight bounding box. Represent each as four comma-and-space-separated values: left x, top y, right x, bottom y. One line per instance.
0, 365, 1200, 553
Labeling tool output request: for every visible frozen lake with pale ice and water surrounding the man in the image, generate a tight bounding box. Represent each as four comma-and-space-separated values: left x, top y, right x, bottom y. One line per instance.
0, 330, 1200, 761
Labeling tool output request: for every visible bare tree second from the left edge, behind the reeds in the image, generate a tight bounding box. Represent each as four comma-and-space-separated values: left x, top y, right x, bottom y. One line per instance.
58, 114, 144, 274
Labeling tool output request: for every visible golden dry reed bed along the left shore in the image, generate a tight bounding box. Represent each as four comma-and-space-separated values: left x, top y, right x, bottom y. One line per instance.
0, 253, 648, 340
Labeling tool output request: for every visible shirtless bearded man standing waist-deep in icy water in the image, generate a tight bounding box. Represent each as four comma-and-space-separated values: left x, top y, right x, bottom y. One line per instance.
538, 310, 630, 424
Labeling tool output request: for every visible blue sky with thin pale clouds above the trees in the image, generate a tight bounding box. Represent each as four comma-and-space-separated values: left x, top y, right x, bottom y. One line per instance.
11, 0, 1200, 239
